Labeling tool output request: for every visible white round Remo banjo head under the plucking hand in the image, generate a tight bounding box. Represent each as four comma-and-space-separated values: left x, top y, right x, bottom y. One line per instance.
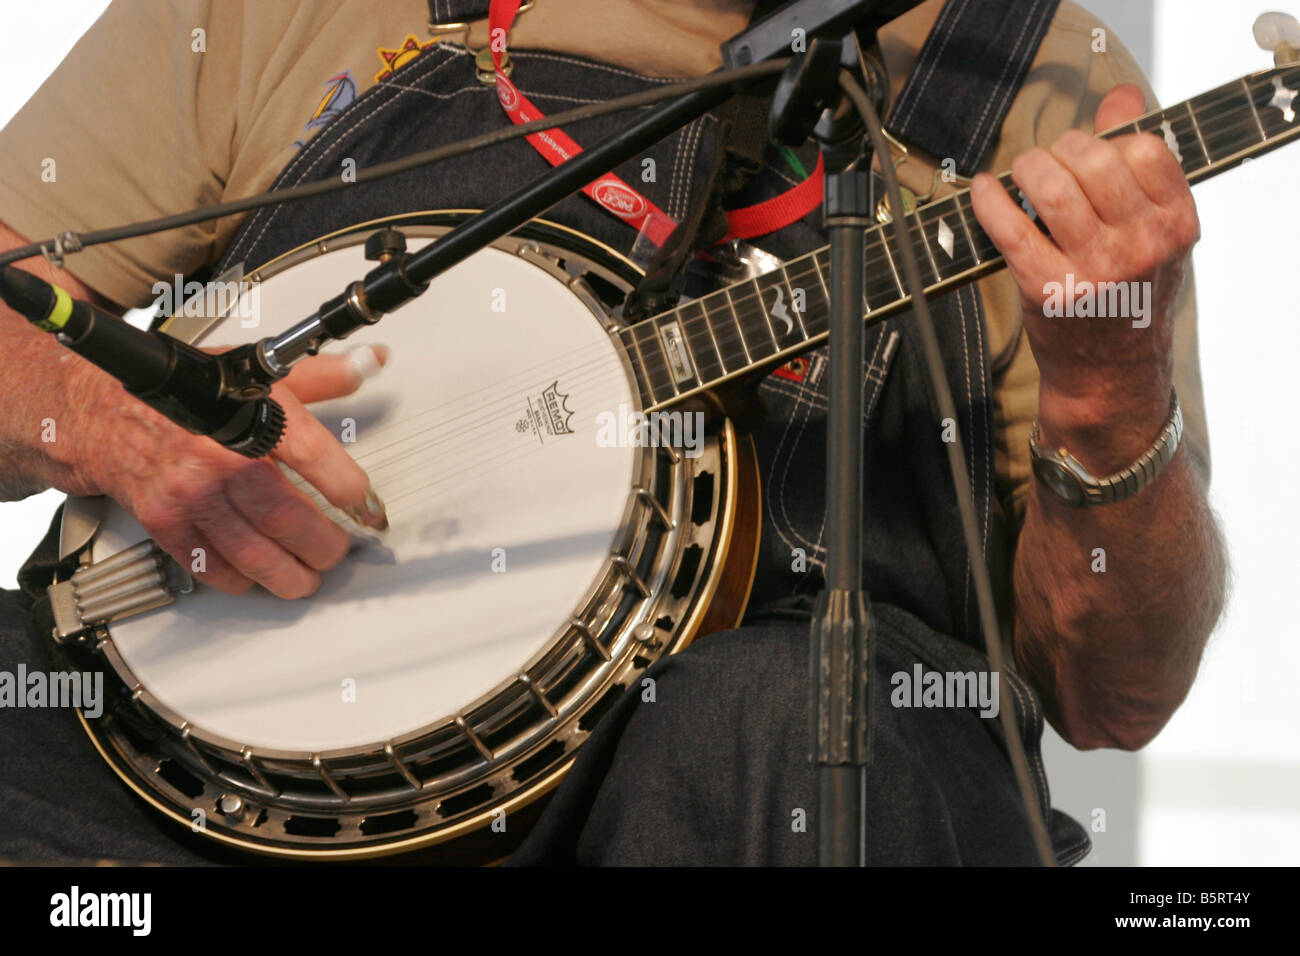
94, 243, 638, 753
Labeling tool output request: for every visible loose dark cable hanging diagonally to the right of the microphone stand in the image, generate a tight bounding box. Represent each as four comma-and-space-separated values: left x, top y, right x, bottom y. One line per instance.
840, 70, 1056, 866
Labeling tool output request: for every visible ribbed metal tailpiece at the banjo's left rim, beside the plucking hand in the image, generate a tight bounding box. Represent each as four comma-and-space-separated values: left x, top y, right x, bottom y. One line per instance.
48, 540, 194, 644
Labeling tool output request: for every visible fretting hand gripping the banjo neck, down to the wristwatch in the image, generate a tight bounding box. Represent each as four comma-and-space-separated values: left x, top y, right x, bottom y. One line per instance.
971, 86, 1200, 473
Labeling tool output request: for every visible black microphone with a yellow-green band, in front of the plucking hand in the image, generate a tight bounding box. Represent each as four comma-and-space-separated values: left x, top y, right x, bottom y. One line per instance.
0, 265, 285, 458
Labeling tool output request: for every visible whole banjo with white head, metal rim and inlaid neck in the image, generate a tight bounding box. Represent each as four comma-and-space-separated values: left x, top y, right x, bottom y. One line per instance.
40, 55, 1300, 862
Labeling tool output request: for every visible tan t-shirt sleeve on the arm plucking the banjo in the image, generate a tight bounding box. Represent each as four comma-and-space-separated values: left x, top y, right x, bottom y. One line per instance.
0, 0, 243, 306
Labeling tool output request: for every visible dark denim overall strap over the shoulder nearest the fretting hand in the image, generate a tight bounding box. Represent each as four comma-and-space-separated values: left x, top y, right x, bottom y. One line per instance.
887, 0, 1060, 177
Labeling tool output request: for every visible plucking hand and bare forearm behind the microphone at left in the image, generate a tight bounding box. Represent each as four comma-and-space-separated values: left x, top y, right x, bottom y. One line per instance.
0, 222, 387, 598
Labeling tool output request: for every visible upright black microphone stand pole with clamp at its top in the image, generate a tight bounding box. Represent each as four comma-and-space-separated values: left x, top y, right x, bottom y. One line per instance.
772, 27, 888, 866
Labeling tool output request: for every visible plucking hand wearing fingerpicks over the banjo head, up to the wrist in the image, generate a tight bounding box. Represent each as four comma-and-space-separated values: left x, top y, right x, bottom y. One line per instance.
60, 350, 387, 598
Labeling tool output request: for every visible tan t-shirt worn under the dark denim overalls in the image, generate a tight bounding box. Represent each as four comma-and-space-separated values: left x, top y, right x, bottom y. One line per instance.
0, 0, 1209, 585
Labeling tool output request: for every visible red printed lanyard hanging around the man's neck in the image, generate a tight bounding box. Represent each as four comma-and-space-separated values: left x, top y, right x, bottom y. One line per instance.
488, 0, 823, 246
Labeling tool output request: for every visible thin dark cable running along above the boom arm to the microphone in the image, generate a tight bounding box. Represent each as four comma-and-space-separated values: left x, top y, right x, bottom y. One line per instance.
0, 59, 789, 265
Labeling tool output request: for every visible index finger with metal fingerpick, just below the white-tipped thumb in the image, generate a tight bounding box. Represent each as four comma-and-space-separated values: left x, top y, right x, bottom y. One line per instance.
263, 386, 389, 531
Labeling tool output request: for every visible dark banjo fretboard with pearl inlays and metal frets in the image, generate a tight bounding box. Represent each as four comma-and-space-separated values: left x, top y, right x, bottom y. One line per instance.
618, 66, 1300, 411
